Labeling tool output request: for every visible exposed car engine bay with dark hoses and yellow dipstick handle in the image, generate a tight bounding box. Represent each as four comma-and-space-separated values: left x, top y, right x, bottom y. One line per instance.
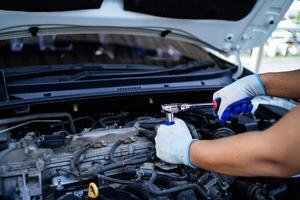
0, 101, 299, 200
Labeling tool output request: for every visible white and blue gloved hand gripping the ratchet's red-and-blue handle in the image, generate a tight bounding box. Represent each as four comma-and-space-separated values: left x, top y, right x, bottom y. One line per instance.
213, 74, 266, 124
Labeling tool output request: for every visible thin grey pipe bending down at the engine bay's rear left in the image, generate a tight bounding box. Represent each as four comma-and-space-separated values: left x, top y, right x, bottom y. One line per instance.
0, 112, 76, 134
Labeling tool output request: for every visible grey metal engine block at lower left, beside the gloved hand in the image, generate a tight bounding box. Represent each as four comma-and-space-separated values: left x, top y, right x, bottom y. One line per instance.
0, 127, 153, 200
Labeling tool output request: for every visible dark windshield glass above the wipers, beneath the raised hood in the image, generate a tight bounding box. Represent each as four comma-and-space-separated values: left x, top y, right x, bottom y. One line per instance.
0, 34, 211, 68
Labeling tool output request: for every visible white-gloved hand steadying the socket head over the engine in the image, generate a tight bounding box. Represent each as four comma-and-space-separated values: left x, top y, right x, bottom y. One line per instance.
155, 118, 194, 167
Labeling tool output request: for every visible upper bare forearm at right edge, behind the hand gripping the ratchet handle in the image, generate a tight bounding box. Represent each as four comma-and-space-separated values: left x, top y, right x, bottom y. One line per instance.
260, 70, 300, 99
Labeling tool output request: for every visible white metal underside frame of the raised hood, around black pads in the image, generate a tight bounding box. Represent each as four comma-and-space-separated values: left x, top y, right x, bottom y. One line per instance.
0, 0, 293, 54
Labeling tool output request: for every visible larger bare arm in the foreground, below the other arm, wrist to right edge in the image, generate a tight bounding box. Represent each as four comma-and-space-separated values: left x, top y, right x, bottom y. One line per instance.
190, 107, 300, 177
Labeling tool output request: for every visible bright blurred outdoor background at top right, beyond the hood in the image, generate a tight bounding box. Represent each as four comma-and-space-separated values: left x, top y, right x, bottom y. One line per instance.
241, 0, 300, 73
